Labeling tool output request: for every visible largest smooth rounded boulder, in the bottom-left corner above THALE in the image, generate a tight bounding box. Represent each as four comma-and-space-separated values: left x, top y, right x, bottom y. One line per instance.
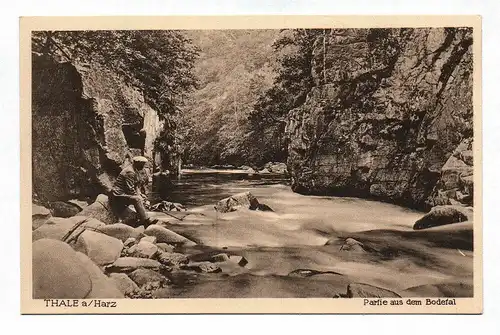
32, 239, 92, 299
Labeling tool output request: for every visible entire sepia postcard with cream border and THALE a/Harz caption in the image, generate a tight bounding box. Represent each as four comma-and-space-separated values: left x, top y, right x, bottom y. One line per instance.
20, 16, 483, 314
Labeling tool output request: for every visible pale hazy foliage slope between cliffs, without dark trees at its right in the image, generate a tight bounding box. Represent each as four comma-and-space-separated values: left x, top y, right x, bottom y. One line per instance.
181, 30, 278, 165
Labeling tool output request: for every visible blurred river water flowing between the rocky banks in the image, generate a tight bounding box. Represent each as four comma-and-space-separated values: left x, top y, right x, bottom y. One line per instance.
151, 170, 472, 297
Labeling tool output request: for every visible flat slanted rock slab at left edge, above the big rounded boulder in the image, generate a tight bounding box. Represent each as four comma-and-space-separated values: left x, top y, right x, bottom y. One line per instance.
32, 216, 104, 241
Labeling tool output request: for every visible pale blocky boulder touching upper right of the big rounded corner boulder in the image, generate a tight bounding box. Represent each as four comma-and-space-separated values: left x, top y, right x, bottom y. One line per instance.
73, 230, 123, 265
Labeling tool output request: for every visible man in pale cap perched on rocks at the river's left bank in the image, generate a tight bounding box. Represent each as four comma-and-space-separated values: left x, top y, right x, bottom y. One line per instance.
111, 156, 158, 228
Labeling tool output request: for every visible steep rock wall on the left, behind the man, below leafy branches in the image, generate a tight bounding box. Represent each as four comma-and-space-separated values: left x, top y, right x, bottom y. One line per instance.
32, 55, 163, 201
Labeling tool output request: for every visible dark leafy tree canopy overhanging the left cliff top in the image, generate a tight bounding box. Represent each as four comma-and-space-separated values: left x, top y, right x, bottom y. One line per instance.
32, 30, 198, 119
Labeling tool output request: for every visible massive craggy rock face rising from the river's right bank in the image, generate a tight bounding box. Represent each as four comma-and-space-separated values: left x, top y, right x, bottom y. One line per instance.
286, 28, 473, 208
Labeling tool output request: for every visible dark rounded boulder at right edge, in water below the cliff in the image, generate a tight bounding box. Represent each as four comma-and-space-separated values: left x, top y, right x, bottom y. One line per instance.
413, 205, 473, 230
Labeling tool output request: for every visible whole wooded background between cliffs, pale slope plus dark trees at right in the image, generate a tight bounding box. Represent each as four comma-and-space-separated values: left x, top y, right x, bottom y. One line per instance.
183, 29, 323, 166
